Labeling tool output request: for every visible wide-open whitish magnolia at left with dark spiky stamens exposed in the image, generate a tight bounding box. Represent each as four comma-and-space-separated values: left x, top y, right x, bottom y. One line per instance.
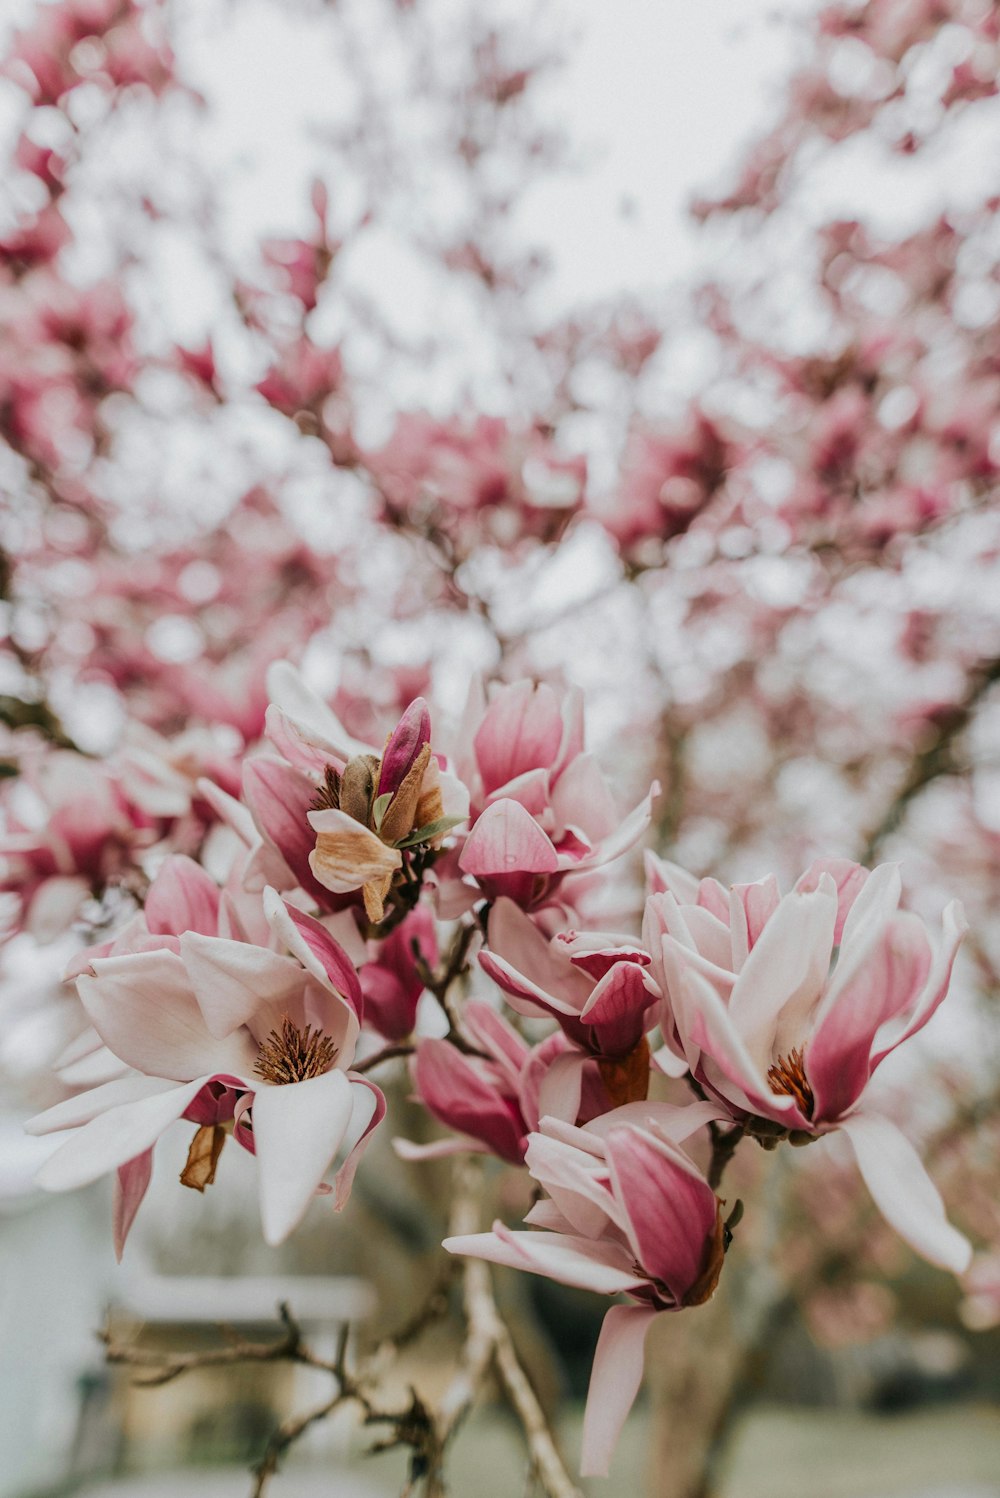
31, 890, 385, 1252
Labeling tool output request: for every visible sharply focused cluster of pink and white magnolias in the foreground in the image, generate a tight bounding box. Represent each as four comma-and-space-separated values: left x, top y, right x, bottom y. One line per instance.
23, 664, 970, 1473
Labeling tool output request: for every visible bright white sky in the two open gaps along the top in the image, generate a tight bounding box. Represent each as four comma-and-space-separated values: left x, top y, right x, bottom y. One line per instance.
166, 0, 811, 306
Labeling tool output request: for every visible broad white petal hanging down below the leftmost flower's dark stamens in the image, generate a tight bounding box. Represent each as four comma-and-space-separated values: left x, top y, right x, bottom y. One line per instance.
251, 1071, 355, 1246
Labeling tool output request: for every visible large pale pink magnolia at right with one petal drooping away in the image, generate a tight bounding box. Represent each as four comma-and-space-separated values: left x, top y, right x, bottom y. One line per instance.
644, 860, 972, 1273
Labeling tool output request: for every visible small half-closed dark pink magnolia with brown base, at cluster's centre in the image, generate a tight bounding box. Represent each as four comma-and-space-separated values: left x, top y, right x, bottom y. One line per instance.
479, 897, 659, 1104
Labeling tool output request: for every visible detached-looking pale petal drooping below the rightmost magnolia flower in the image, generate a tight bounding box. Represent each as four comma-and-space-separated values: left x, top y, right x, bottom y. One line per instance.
840, 1113, 972, 1275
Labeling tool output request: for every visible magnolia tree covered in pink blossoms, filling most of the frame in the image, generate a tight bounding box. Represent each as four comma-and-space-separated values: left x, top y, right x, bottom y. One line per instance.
0, 0, 1000, 1498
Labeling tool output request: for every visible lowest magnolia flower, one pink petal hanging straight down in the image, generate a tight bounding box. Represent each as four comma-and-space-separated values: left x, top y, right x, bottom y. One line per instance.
445, 1103, 728, 1477
